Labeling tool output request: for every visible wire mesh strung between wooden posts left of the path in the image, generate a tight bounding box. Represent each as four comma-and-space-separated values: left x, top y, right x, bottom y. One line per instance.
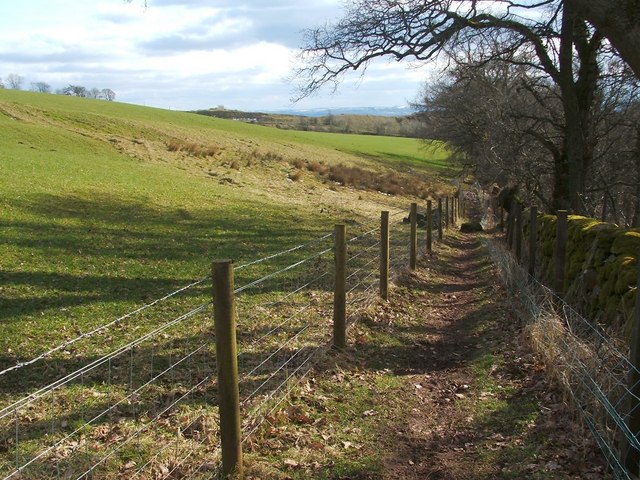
0, 212, 418, 480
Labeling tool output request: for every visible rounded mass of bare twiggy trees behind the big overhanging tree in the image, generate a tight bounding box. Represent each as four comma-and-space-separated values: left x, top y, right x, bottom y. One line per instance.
416, 50, 562, 209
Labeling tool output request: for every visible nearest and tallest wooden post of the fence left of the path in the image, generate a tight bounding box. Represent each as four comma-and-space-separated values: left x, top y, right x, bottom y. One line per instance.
212, 260, 243, 479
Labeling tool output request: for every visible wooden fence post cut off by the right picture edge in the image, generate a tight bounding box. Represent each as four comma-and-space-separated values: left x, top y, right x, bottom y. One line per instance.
624, 251, 640, 478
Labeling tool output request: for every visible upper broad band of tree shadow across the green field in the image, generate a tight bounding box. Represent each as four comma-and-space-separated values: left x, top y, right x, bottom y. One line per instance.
0, 191, 328, 265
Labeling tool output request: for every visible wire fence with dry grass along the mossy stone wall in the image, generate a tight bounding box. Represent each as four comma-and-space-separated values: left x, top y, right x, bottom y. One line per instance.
488, 241, 640, 480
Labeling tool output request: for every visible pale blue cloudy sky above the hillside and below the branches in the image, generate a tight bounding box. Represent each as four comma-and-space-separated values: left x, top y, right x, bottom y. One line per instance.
0, 0, 429, 111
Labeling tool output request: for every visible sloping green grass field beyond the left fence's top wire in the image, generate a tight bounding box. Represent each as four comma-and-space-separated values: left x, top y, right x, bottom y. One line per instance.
0, 90, 445, 360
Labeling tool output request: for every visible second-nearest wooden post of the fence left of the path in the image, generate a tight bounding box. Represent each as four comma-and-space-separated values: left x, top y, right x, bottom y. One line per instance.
333, 225, 347, 349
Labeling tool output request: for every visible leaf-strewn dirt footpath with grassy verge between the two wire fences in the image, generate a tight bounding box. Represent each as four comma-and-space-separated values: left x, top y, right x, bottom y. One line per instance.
242, 231, 609, 480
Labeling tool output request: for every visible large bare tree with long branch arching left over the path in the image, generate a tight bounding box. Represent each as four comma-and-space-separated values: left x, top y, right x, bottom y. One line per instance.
296, 0, 603, 212
